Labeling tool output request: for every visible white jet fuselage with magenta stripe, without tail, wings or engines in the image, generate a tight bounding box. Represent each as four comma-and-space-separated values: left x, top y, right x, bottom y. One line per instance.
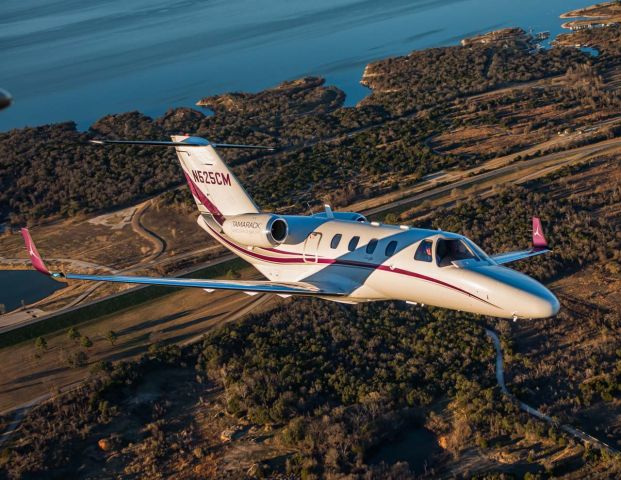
198, 215, 559, 318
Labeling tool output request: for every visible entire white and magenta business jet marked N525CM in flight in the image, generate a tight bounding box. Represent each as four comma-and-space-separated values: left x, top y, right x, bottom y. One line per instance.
22, 135, 559, 320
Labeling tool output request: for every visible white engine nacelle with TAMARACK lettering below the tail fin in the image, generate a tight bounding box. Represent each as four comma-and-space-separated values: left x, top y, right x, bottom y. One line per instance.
222, 213, 289, 248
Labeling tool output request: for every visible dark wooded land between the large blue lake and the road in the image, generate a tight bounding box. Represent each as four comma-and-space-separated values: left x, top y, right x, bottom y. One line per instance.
0, 32, 594, 225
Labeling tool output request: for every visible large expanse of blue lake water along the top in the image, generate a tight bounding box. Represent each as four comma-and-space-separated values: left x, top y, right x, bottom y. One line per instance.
0, 0, 592, 131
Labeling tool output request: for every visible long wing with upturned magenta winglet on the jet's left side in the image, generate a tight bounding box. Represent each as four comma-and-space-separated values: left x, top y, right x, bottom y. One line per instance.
21, 228, 345, 296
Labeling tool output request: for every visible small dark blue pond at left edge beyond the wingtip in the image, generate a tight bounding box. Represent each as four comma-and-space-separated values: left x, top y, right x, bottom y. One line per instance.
0, 270, 66, 312
